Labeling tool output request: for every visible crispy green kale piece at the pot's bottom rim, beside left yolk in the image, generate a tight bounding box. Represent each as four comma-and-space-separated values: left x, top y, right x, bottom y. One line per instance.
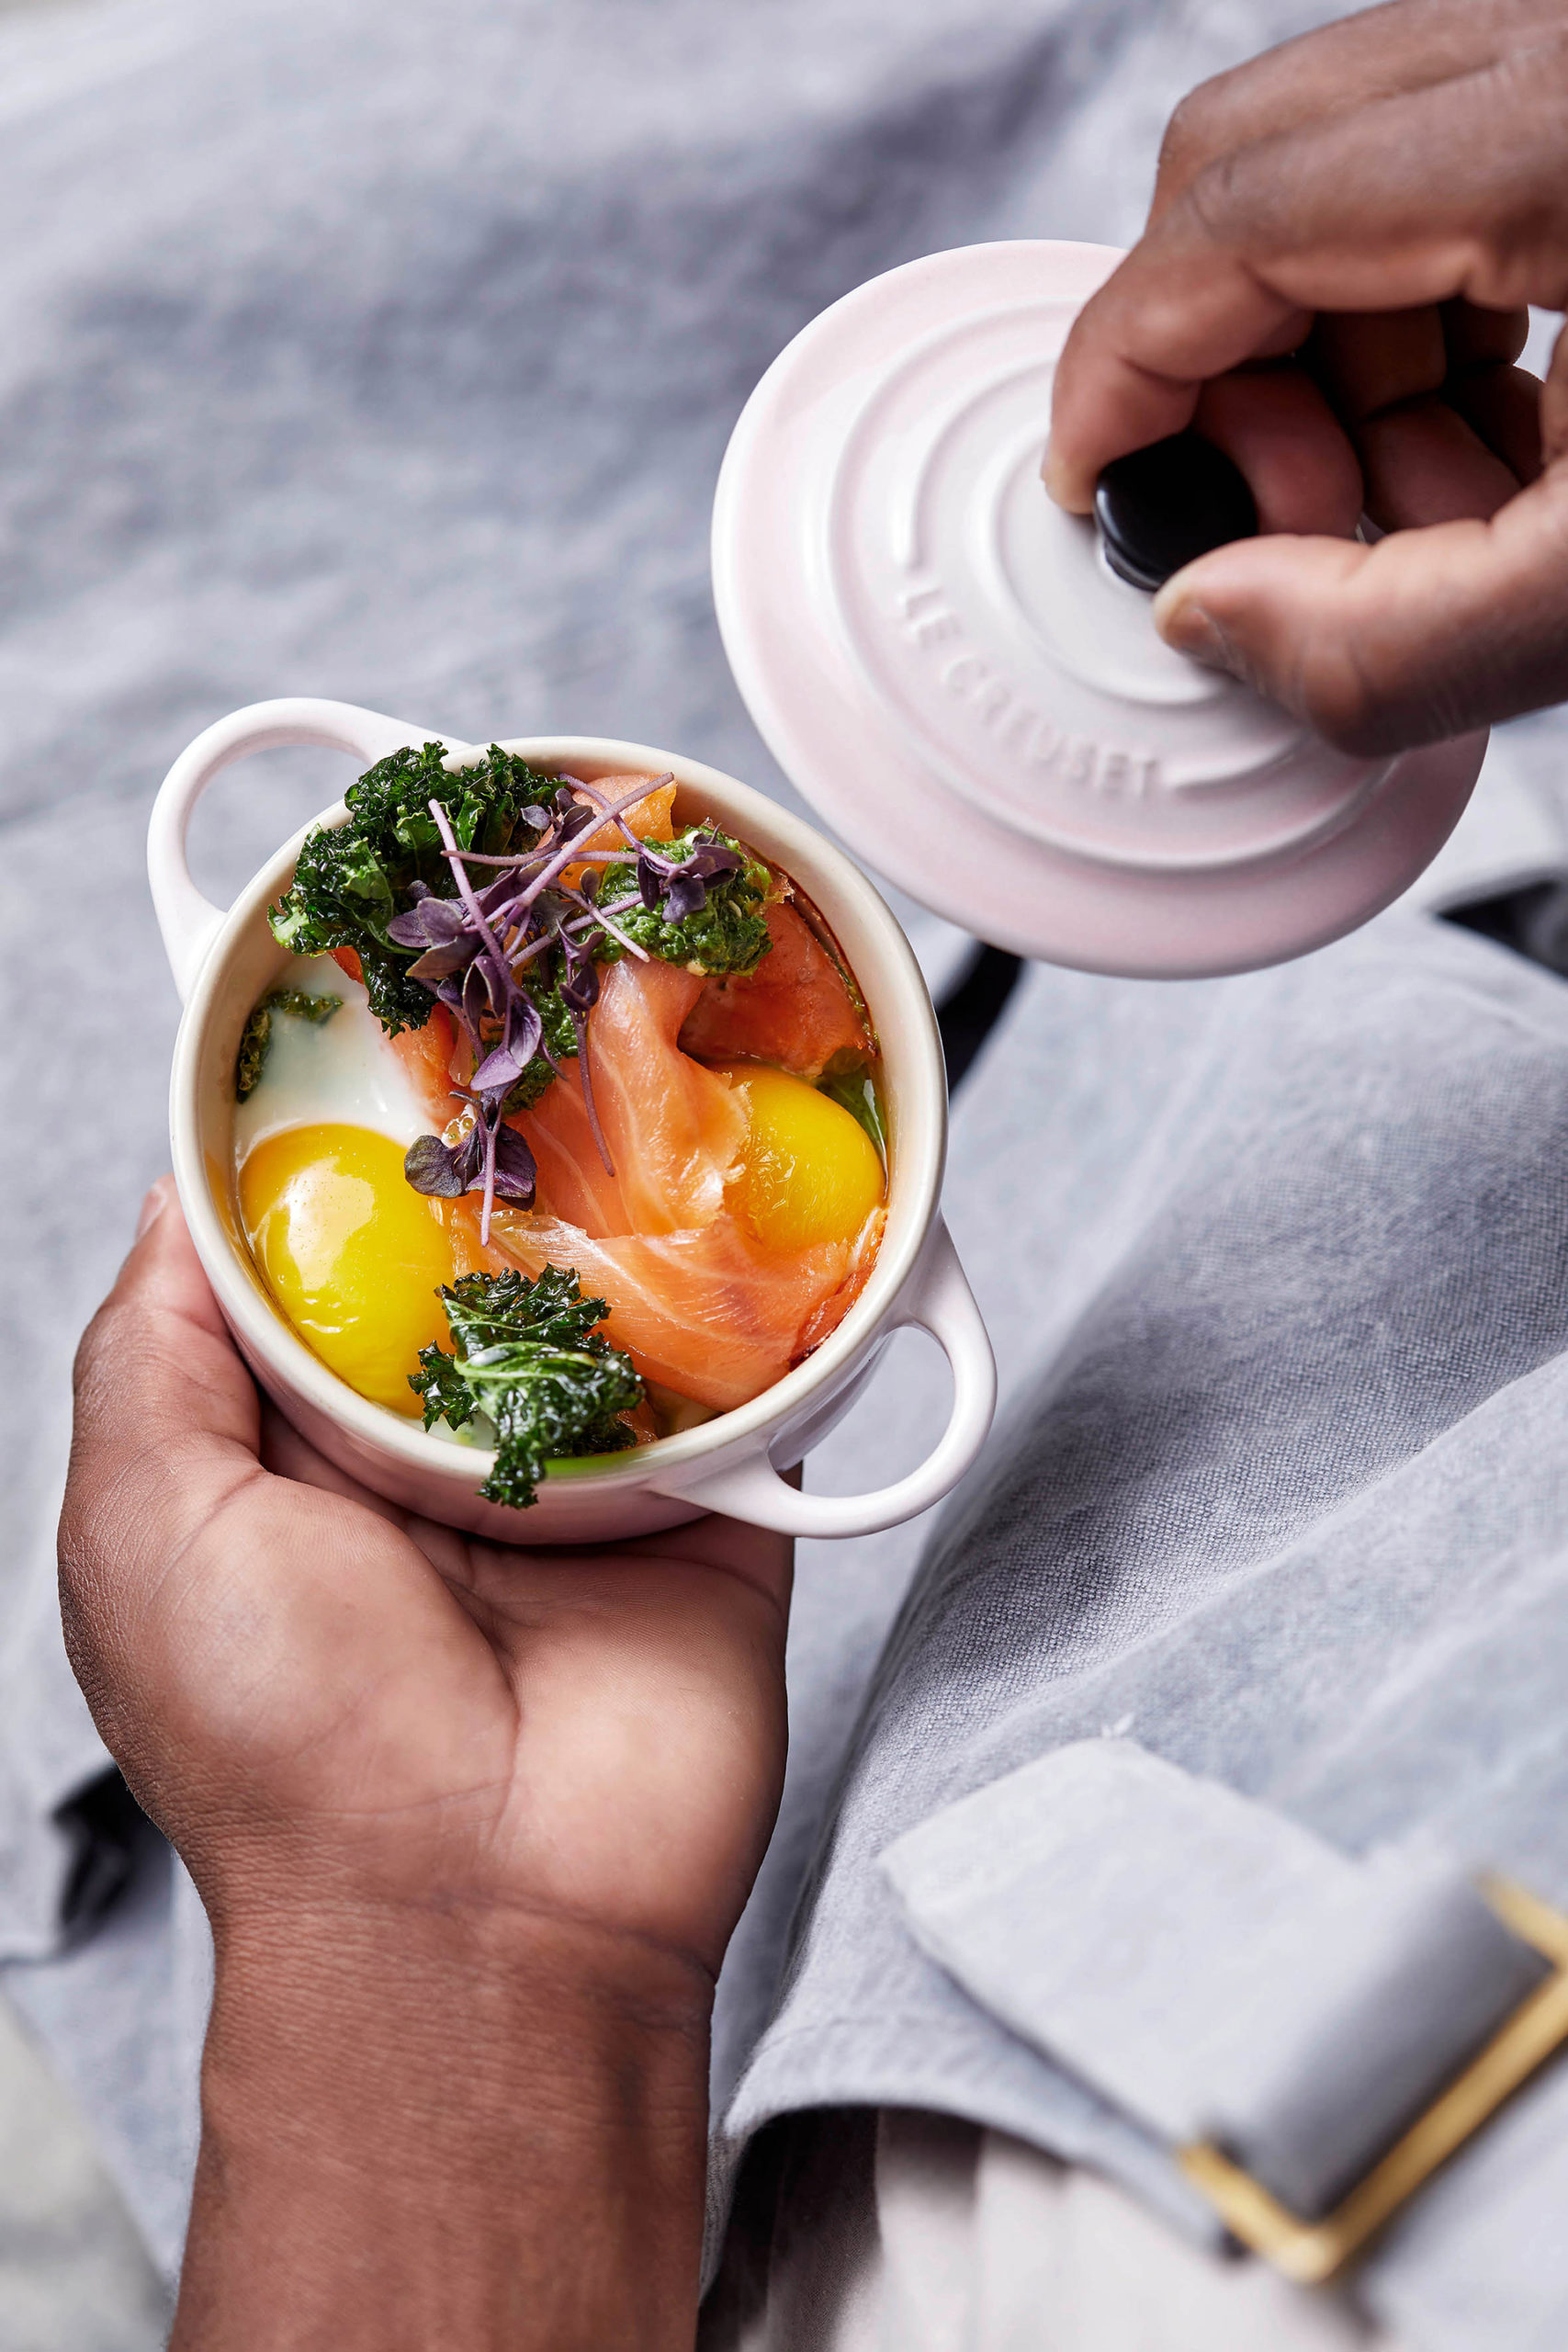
409, 1265, 642, 1510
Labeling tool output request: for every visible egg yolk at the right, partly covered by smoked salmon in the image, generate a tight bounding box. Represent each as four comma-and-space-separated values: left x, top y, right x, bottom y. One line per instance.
719, 1061, 886, 1249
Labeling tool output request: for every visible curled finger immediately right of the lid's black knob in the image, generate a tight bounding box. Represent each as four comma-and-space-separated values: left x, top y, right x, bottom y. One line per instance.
1194, 367, 1361, 538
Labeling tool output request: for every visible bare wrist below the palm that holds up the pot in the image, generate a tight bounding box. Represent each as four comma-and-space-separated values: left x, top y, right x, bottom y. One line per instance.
174, 1905, 712, 2352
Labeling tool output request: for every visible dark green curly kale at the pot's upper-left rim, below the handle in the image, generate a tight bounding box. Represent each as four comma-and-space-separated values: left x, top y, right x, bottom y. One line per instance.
270, 743, 555, 1037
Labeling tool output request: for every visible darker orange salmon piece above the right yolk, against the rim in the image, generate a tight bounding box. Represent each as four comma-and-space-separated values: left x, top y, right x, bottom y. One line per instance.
680, 900, 874, 1080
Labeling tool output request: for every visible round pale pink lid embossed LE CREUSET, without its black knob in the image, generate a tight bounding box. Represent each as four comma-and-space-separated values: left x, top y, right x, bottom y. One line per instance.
712, 243, 1485, 976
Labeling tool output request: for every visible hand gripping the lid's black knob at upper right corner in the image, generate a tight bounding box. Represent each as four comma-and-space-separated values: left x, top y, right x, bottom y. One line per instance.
1048, 0, 1568, 757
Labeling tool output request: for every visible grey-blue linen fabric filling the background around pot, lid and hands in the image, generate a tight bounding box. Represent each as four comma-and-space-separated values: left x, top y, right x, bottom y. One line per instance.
0, 0, 1568, 2324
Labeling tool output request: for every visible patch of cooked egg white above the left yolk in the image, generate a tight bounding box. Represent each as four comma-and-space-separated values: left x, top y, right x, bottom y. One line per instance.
235, 955, 434, 1167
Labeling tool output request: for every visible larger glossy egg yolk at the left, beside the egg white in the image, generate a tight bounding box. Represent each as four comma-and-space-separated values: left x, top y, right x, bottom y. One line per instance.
240, 1125, 456, 1416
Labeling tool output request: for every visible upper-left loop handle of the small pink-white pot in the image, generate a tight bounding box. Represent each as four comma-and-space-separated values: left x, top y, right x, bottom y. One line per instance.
148, 694, 446, 1004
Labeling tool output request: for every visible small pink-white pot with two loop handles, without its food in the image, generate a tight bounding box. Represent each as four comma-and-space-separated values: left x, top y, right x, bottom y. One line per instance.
148, 701, 995, 1543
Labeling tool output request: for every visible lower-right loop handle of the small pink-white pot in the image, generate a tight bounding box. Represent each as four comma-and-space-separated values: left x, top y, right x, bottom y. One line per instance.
660, 1216, 997, 1536
